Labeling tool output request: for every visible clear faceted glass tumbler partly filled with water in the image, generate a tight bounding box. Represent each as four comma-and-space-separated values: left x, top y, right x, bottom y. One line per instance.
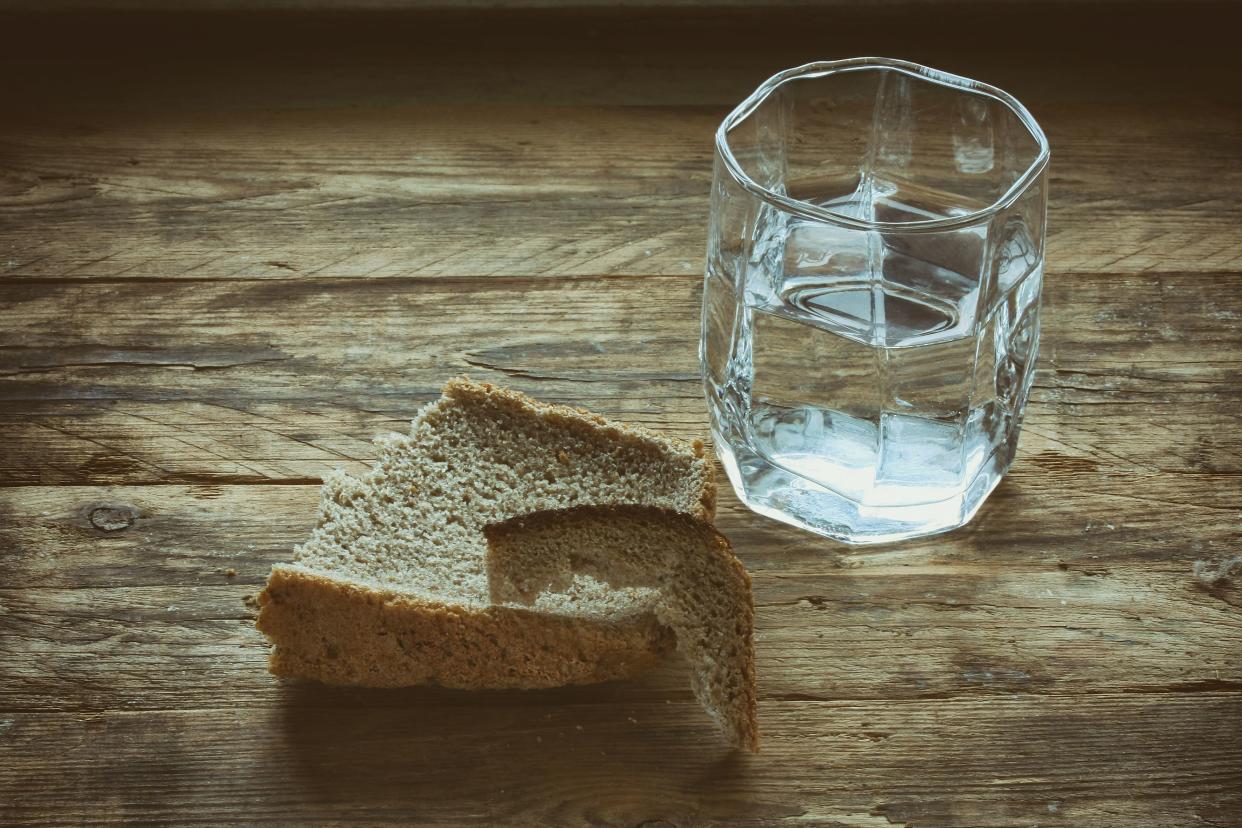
699, 58, 1048, 544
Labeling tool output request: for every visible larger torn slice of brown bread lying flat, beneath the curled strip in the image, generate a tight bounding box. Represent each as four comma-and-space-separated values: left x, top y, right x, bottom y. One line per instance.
257, 379, 715, 688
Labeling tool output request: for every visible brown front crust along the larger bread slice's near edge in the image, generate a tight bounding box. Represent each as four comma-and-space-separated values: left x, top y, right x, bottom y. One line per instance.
257, 566, 674, 689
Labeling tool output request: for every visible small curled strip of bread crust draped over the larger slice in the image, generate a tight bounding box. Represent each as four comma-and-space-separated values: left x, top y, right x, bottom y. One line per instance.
483, 505, 759, 751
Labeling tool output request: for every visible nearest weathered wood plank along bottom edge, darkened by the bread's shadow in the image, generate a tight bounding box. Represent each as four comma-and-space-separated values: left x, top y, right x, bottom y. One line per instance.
0, 688, 1242, 828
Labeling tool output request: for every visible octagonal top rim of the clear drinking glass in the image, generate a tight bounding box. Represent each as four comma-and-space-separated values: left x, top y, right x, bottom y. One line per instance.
715, 57, 1049, 232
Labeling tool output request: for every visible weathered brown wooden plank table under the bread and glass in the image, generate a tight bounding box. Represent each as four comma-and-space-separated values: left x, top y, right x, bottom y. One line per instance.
0, 2, 1242, 828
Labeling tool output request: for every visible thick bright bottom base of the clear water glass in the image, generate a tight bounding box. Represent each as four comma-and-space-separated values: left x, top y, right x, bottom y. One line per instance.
712, 432, 1012, 545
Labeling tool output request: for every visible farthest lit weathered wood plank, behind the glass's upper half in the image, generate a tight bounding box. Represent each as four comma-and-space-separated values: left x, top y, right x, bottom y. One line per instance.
0, 103, 1242, 279
